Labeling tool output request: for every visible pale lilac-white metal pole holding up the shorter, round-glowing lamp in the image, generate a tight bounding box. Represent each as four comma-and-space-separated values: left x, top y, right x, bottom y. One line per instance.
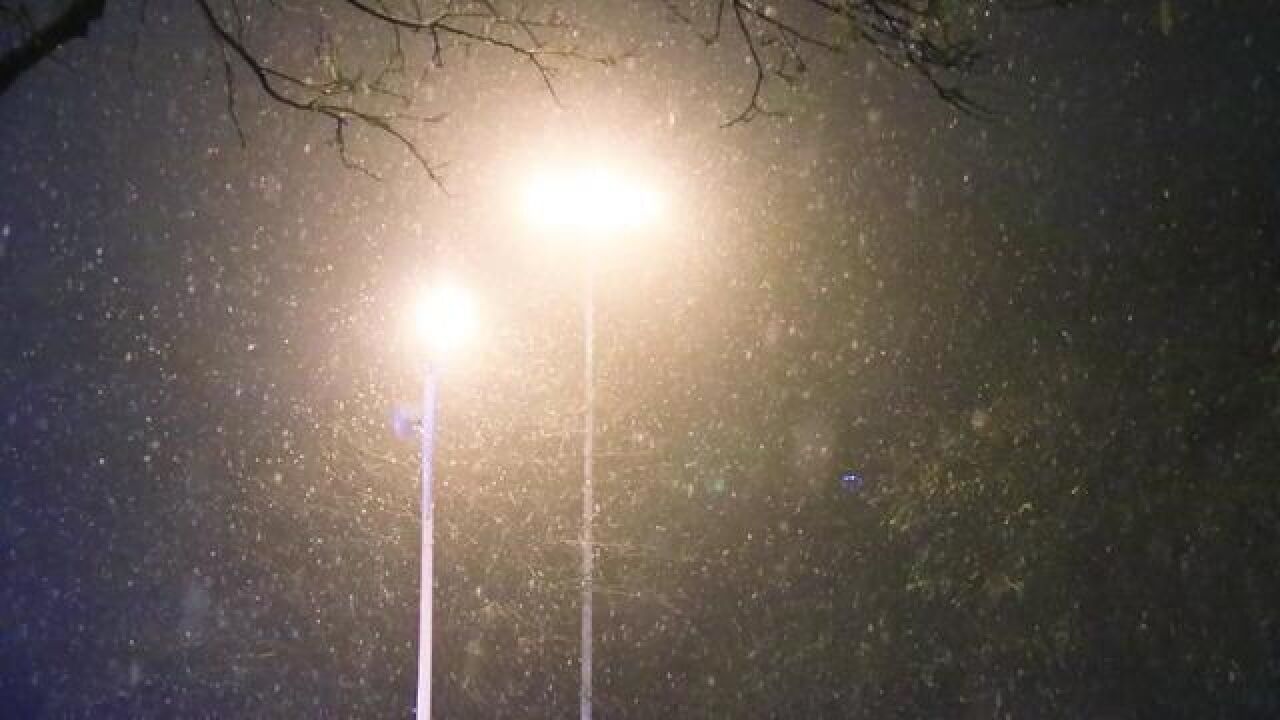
417, 364, 438, 719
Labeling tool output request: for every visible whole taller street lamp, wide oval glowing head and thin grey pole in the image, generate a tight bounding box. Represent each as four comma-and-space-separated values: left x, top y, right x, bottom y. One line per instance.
525, 168, 662, 720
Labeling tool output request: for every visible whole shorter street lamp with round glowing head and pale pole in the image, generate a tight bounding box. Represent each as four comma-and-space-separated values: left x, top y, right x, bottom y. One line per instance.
412, 279, 476, 719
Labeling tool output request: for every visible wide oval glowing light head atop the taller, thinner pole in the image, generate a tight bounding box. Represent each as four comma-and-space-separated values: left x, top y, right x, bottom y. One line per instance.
525, 169, 662, 232
